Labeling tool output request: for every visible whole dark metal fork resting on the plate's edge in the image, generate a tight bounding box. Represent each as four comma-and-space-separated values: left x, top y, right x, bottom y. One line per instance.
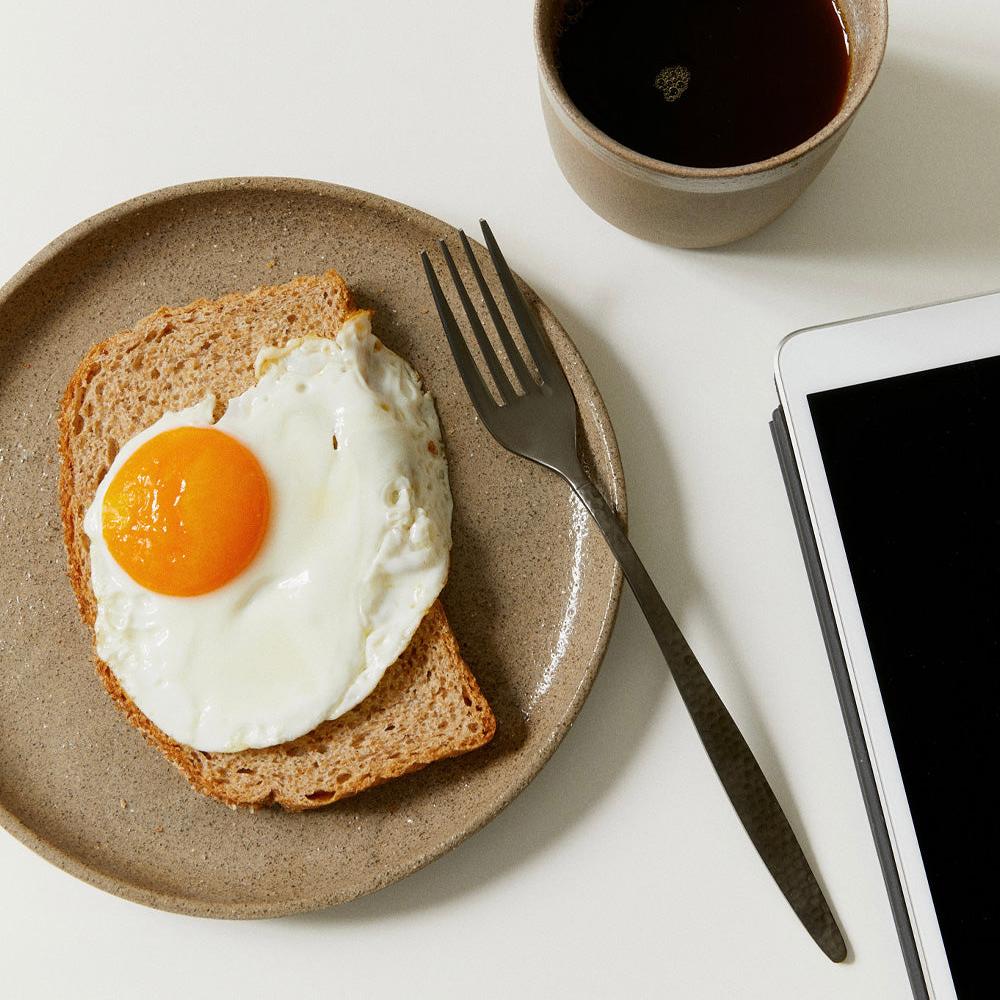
420, 220, 847, 962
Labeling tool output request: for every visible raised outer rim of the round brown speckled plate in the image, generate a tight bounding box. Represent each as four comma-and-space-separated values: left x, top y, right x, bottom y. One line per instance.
0, 175, 628, 919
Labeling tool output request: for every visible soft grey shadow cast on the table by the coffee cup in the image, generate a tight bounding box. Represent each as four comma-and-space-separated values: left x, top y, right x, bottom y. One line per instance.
724, 47, 1000, 263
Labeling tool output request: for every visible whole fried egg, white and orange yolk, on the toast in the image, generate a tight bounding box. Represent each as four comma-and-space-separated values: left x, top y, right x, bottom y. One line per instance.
84, 313, 452, 752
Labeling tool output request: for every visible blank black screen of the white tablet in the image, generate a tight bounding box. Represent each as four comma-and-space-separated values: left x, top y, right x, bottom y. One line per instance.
809, 358, 1000, 1000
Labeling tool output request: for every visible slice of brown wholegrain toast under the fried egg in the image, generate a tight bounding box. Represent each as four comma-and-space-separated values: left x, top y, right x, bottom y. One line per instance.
59, 271, 496, 810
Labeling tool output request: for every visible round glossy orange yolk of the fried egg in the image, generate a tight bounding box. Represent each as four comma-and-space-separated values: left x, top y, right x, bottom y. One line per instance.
102, 427, 271, 597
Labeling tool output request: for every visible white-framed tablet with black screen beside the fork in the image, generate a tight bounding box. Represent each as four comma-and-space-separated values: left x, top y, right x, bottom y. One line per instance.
775, 293, 1000, 1000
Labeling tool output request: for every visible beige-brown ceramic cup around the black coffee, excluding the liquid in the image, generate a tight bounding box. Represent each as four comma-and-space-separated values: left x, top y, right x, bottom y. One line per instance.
535, 0, 889, 247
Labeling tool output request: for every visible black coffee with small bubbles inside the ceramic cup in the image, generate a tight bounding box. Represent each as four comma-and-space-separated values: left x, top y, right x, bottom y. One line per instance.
556, 0, 850, 167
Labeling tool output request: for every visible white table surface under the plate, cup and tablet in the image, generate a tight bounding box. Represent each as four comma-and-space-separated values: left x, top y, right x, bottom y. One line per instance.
0, 0, 1000, 1000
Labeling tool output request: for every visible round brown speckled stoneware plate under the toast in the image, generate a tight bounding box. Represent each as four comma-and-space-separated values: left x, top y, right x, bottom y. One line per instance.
0, 178, 625, 917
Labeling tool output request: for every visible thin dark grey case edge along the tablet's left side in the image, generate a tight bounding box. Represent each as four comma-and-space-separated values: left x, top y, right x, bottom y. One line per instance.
771, 406, 929, 1000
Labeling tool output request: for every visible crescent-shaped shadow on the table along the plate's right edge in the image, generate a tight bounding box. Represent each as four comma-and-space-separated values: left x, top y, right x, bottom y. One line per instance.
288, 284, 691, 924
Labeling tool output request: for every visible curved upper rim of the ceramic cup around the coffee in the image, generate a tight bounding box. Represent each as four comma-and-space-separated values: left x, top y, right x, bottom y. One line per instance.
533, 0, 889, 180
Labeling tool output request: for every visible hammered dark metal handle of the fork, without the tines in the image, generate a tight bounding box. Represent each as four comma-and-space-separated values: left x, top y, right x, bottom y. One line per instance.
566, 469, 847, 962
